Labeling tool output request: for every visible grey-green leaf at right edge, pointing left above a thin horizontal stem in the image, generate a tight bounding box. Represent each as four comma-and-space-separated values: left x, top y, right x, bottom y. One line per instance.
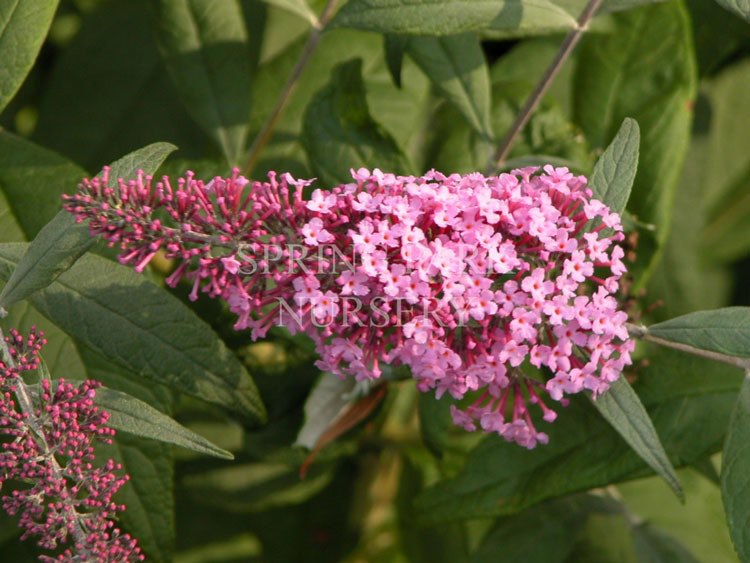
648, 307, 750, 358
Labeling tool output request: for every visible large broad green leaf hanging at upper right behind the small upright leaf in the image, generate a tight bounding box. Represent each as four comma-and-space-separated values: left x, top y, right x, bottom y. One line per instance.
574, 2, 696, 289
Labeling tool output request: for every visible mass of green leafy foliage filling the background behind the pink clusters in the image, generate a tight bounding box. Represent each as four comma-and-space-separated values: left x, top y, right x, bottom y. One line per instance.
0, 0, 750, 563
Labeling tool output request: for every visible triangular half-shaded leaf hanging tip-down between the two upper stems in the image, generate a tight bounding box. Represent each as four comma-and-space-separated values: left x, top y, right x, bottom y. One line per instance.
408, 33, 493, 140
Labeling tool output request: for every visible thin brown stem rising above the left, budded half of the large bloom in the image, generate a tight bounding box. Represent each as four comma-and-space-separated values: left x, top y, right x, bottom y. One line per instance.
242, 0, 336, 177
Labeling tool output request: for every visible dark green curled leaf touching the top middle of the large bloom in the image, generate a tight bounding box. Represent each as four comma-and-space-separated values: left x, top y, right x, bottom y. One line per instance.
303, 59, 411, 185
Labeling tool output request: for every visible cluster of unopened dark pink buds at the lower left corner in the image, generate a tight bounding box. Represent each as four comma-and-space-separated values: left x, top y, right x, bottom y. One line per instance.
0, 328, 143, 563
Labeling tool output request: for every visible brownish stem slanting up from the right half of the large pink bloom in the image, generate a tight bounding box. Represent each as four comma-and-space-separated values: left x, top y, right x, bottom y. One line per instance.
486, 0, 603, 174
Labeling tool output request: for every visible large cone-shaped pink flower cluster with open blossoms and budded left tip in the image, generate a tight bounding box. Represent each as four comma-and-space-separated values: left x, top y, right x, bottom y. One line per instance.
65, 166, 633, 448
